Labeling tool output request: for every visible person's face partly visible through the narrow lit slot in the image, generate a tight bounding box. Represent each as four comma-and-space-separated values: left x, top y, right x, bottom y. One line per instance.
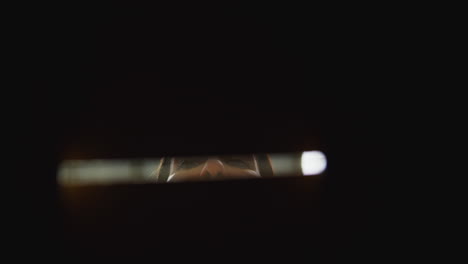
168, 155, 260, 182
